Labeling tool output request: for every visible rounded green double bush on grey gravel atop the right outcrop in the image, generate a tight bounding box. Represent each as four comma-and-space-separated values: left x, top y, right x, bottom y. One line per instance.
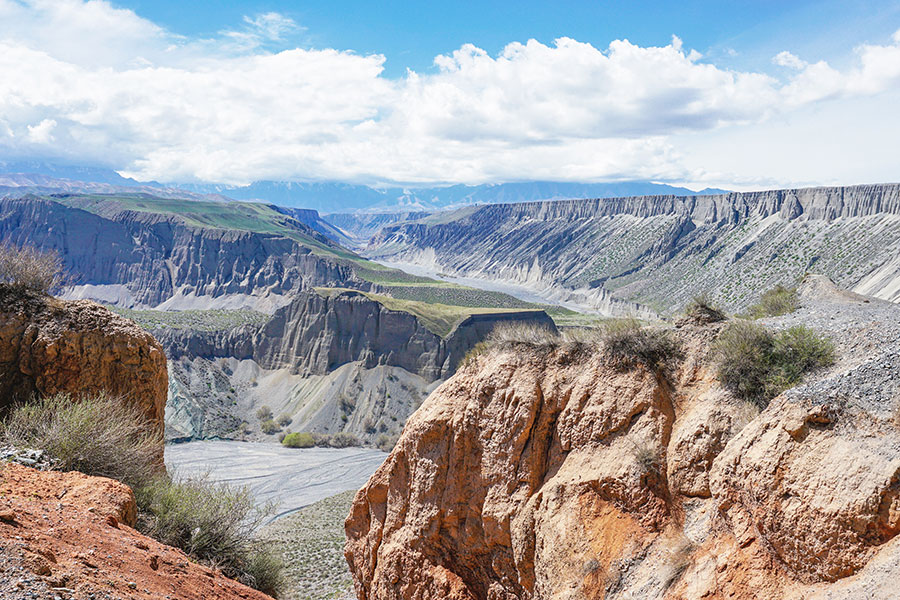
713, 321, 834, 408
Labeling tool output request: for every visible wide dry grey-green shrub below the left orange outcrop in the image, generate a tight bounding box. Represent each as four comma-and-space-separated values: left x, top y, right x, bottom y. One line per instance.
0, 394, 163, 487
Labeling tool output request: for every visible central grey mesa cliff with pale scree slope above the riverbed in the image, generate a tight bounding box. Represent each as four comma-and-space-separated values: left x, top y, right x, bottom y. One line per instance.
154, 291, 555, 443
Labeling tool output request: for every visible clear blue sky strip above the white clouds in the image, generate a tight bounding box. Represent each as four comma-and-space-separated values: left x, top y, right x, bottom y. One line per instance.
112, 0, 900, 77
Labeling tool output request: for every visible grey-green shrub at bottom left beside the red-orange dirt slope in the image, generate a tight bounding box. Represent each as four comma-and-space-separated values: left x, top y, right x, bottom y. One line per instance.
135, 477, 281, 593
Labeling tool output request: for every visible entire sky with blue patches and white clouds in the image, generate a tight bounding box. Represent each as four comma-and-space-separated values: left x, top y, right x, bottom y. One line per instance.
0, 0, 900, 189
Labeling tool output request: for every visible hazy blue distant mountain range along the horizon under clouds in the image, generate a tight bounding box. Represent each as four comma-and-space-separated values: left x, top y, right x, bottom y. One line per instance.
0, 161, 725, 214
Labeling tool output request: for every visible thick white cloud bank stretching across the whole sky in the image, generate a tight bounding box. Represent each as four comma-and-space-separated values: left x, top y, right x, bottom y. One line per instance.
0, 0, 900, 188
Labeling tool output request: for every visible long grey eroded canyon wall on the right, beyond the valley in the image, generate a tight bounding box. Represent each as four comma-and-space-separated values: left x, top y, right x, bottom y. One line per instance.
366, 184, 900, 314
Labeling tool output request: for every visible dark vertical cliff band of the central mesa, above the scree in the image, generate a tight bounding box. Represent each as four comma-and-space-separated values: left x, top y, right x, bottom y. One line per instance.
156, 291, 555, 381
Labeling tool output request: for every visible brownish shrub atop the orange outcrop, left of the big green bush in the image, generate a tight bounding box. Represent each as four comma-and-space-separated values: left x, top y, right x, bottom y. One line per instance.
601, 319, 682, 369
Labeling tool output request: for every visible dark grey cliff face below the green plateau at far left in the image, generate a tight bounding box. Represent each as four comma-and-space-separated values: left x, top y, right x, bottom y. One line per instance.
0, 197, 362, 308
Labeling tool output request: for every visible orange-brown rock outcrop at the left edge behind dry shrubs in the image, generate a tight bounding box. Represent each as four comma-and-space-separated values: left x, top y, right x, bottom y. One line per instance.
0, 287, 167, 429
